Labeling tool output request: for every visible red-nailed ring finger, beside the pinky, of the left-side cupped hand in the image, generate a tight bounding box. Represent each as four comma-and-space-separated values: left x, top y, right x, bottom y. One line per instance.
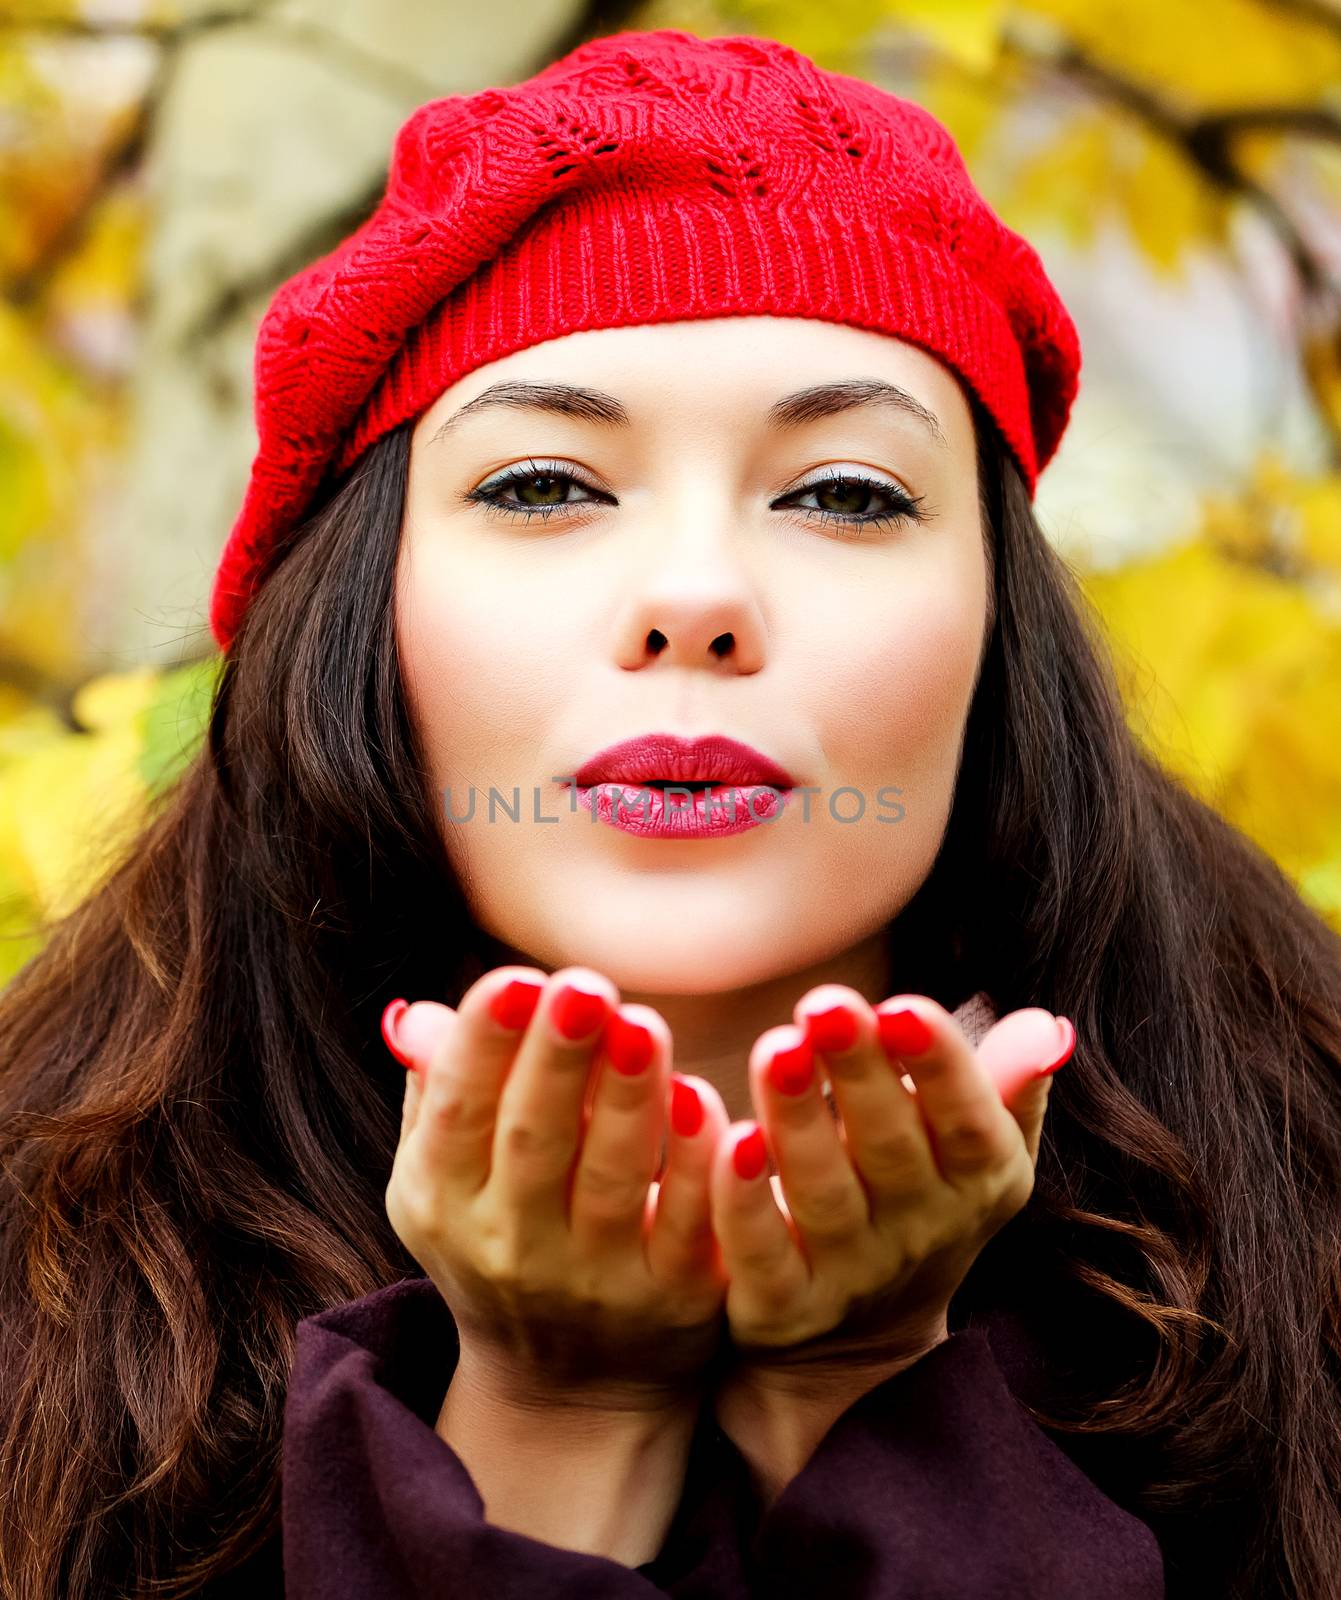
568, 1003, 671, 1251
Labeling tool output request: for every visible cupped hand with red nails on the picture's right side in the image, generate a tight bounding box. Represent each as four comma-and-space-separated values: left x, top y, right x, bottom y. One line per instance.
712, 984, 1075, 1381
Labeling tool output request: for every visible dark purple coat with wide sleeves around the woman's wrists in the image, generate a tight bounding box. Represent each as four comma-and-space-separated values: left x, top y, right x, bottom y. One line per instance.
257, 1277, 1171, 1600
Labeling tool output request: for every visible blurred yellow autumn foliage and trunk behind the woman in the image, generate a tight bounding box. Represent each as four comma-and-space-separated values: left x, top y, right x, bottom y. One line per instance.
0, 0, 1341, 984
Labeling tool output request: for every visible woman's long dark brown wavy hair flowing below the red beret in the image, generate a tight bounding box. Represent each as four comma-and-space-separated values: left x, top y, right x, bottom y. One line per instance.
0, 394, 1341, 1600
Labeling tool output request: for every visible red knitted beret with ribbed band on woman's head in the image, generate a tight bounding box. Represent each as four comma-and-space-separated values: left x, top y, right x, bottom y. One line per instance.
210, 29, 1080, 650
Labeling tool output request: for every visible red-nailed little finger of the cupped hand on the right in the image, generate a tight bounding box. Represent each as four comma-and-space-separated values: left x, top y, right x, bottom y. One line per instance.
709, 1122, 810, 1326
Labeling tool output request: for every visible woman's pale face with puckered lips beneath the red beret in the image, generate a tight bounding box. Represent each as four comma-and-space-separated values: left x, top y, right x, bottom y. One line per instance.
397, 317, 989, 995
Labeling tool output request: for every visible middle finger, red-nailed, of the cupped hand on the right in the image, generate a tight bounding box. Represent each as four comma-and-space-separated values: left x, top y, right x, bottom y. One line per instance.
795, 984, 941, 1206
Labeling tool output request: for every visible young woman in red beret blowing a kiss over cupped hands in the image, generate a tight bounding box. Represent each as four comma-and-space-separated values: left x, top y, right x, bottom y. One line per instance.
0, 30, 1341, 1600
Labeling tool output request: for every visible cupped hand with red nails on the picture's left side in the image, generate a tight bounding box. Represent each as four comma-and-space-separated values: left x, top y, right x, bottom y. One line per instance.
384, 966, 728, 1411
